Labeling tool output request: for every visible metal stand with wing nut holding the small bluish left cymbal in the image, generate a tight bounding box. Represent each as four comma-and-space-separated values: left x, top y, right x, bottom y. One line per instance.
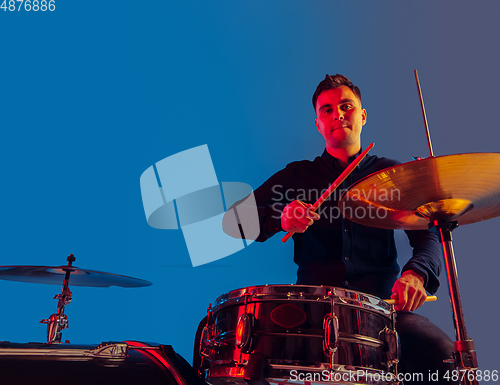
40, 254, 76, 344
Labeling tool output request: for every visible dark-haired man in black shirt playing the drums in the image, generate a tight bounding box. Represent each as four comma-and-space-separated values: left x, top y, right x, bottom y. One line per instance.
225, 74, 454, 384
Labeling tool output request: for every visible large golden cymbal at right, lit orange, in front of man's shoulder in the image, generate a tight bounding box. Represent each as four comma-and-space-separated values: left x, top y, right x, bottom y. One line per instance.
339, 153, 500, 230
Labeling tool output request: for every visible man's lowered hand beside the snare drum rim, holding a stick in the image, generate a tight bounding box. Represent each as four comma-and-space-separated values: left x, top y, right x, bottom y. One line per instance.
391, 270, 427, 311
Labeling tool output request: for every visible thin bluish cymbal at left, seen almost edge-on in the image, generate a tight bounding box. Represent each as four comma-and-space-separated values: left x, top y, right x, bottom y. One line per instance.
0, 266, 152, 287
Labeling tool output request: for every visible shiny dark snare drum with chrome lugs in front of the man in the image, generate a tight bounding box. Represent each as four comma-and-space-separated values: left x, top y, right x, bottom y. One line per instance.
200, 285, 398, 385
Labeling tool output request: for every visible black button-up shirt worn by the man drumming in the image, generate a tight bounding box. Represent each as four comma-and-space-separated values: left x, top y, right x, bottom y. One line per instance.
254, 150, 441, 298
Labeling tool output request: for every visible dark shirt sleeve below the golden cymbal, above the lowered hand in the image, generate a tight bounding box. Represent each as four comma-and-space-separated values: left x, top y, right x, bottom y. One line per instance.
402, 230, 443, 294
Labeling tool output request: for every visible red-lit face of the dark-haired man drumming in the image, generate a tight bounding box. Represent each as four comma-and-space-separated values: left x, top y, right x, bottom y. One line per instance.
315, 86, 366, 153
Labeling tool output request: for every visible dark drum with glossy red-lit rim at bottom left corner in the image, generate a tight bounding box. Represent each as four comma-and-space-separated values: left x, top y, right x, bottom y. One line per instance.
0, 341, 204, 385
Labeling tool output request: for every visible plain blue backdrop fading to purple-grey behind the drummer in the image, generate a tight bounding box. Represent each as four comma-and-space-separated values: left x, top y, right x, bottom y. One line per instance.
0, 0, 500, 378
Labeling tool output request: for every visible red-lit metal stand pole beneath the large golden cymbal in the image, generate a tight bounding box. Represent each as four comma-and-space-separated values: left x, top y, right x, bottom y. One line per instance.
429, 219, 479, 385
